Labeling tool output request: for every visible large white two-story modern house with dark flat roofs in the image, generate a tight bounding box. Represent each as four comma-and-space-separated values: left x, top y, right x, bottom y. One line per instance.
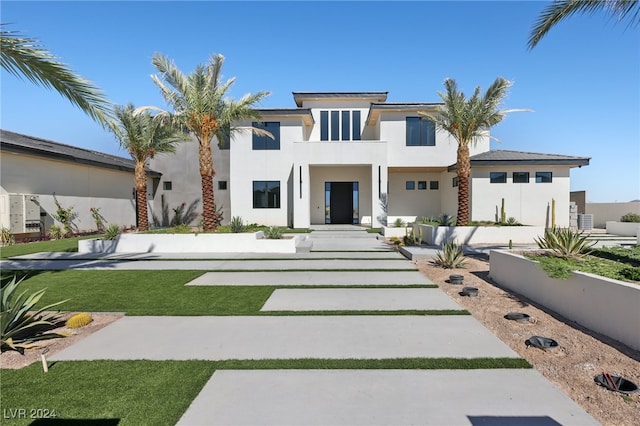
151, 92, 590, 228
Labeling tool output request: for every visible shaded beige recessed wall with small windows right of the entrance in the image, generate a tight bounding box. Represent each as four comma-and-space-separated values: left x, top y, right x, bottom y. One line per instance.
388, 173, 443, 218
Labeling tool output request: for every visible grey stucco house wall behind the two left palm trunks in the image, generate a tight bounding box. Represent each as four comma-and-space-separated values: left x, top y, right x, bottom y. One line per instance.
149, 138, 234, 225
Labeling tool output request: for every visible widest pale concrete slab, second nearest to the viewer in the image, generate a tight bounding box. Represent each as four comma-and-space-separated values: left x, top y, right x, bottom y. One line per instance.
51, 315, 519, 361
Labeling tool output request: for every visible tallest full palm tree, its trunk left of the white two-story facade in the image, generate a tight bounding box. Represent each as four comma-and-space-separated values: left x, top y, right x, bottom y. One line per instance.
151, 54, 269, 231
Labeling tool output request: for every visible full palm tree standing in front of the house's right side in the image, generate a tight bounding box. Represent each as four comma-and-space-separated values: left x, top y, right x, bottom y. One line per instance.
419, 77, 523, 226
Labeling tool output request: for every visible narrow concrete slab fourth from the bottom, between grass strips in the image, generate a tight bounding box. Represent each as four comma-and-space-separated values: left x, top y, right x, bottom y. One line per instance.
187, 270, 433, 286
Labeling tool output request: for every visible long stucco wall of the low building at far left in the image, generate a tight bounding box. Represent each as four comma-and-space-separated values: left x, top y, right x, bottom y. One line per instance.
0, 151, 139, 232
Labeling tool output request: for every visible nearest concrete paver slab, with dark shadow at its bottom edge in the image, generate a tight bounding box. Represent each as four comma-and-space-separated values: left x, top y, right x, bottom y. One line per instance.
178, 369, 598, 426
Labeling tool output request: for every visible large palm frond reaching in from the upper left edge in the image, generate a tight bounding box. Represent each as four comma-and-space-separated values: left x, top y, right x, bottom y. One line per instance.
0, 24, 112, 127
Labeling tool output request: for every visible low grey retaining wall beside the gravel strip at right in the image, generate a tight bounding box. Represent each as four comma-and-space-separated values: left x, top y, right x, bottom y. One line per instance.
490, 250, 640, 350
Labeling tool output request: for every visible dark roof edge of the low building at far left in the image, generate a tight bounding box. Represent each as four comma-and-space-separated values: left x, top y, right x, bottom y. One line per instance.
0, 130, 162, 178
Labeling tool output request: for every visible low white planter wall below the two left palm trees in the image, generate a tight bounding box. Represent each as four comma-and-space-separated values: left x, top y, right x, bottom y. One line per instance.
78, 231, 307, 253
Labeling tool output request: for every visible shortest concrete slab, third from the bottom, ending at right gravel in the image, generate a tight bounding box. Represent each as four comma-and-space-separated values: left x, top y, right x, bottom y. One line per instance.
261, 288, 464, 311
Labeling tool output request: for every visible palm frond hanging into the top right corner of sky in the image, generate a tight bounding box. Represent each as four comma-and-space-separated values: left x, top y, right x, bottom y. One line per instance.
527, 0, 640, 49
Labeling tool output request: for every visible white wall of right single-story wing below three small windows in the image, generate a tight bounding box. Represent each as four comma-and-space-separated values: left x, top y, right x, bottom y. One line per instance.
471, 165, 569, 227
